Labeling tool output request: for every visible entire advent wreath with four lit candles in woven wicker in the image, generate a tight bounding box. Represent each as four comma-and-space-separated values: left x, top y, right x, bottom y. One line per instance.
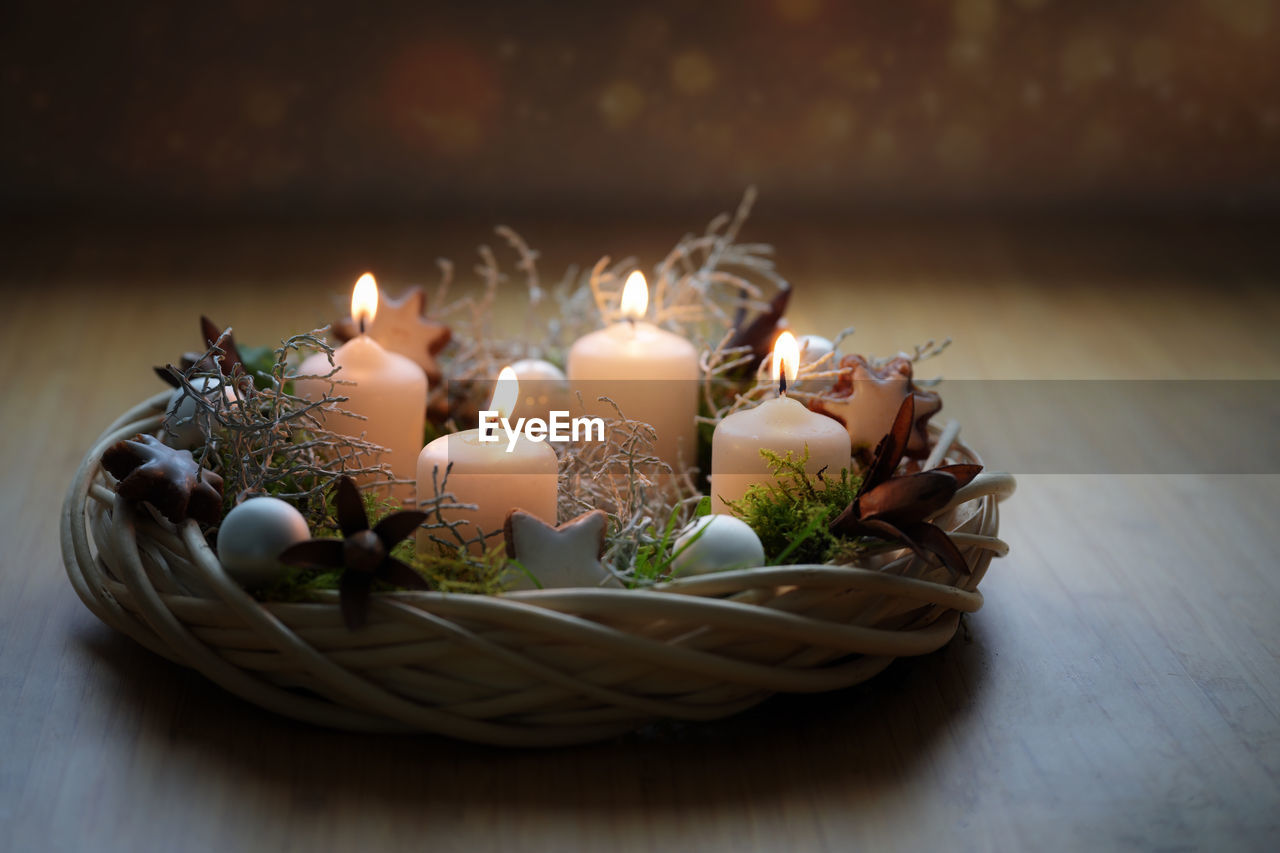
61, 191, 1014, 745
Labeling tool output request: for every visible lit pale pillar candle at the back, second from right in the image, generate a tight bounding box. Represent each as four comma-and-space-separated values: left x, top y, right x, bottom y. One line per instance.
567, 272, 699, 471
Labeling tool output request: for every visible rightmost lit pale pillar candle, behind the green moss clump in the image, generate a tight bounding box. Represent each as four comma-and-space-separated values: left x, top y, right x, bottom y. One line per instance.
710, 332, 851, 514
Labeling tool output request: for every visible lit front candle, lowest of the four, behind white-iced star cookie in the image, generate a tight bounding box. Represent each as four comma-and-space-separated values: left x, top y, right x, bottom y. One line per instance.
417, 368, 558, 552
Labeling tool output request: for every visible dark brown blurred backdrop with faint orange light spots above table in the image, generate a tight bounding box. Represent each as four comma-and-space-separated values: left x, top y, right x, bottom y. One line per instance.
0, 0, 1280, 225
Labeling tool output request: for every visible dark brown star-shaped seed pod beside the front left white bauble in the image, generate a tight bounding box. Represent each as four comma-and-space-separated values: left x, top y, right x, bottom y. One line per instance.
279, 476, 428, 630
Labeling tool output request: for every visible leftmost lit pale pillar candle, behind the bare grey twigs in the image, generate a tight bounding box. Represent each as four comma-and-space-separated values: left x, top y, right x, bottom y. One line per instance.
294, 273, 426, 500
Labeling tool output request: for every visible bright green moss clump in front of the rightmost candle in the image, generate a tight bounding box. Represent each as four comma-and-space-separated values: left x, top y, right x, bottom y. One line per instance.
728, 447, 861, 565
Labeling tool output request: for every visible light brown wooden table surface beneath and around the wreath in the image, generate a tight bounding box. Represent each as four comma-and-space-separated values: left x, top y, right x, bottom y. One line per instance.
0, 216, 1280, 852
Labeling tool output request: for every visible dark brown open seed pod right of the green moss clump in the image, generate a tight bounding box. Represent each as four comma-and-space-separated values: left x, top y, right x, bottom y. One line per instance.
831, 394, 982, 574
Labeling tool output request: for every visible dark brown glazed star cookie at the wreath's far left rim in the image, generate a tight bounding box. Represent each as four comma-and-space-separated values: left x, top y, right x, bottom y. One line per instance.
102, 434, 223, 524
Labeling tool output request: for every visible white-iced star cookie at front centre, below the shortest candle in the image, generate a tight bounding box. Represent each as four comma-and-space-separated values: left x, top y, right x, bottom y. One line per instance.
503, 510, 622, 589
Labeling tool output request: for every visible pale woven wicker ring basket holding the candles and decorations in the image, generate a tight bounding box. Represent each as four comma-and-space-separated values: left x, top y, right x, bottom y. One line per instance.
61, 393, 1014, 747
